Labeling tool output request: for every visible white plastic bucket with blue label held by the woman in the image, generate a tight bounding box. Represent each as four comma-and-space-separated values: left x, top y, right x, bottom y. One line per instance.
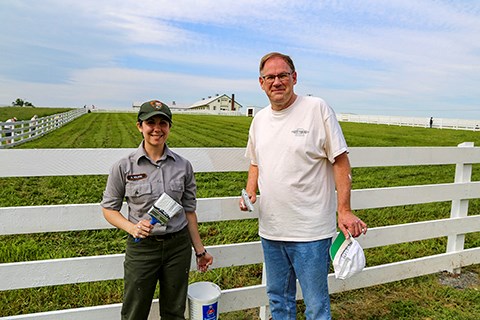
188, 281, 222, 320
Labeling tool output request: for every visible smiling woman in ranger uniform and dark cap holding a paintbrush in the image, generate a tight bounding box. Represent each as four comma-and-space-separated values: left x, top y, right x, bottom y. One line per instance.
101, 100, 213, 320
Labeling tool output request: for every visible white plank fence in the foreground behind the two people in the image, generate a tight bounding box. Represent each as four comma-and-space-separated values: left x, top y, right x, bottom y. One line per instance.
0, 143, 480, 320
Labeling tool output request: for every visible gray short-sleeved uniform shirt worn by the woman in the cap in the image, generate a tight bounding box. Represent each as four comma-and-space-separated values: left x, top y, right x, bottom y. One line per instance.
100, 141, 197, 235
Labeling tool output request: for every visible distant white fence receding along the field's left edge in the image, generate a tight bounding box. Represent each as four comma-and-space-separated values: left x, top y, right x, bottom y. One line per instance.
0, 108, 87, 149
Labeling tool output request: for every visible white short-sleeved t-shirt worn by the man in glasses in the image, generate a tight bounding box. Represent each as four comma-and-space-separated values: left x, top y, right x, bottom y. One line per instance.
245, 96, 348, 241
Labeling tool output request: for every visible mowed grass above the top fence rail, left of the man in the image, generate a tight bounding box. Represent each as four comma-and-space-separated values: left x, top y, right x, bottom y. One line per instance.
18, 113, 251, 149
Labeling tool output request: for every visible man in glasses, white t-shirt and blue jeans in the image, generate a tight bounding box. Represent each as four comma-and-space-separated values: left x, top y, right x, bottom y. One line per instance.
240, 52, 367, 320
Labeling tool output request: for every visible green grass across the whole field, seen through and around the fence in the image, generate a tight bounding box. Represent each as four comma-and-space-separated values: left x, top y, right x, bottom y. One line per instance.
0, 108, 480, 320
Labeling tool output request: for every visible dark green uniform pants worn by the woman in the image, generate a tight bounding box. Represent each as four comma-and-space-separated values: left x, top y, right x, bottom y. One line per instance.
122, 227, 192, 320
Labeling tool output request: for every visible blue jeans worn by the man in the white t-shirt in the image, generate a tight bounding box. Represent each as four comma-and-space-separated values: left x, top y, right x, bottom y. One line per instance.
262, 238, 332, 320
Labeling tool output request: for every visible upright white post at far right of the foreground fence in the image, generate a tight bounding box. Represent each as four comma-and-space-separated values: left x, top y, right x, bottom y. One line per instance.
447, 142, 474, 274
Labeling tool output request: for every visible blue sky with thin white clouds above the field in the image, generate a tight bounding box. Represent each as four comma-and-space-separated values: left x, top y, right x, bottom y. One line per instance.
0, 0, 480, 119
